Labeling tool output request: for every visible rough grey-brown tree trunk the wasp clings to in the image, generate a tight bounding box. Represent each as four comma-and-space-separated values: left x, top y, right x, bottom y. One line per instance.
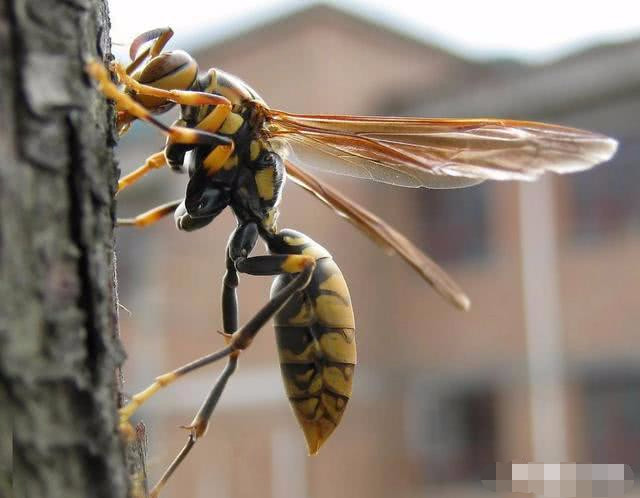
0, 0, 141, 498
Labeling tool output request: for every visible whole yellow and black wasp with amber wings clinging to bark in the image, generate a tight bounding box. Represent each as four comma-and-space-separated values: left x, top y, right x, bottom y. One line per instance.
87, 28, 617, 496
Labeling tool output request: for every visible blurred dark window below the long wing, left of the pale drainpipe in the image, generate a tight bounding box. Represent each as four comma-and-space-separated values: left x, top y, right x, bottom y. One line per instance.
419, 185, 488, 262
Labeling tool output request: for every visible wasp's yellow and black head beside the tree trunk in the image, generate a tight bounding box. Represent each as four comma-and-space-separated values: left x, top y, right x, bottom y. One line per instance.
132, 50, 198, 112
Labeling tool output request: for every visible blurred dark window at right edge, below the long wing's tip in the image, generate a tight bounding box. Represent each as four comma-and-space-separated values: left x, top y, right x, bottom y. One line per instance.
568, 137, 640, 240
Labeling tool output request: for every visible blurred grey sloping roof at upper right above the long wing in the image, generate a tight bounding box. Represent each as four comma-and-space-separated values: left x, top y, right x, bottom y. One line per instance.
407, 39, 640, 118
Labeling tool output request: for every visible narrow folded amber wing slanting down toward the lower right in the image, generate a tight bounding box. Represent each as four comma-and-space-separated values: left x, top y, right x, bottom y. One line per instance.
285, 160, 470, 310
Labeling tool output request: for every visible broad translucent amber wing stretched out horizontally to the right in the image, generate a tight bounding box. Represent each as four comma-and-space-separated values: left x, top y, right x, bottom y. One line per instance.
266, 109, 617, 188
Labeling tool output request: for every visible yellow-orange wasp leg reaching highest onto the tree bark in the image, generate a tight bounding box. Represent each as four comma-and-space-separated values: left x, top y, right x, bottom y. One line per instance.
86, 61, 234, 149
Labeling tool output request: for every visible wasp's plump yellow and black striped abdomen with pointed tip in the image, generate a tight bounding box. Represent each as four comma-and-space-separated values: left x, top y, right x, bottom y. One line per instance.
272, 233, 356, 455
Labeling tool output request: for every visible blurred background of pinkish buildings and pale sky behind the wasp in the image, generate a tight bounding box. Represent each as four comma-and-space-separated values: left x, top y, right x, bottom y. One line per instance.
111, 0, 640, 498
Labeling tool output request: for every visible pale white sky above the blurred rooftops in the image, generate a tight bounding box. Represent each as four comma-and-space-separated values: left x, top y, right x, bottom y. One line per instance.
109, 0, 640, 63
